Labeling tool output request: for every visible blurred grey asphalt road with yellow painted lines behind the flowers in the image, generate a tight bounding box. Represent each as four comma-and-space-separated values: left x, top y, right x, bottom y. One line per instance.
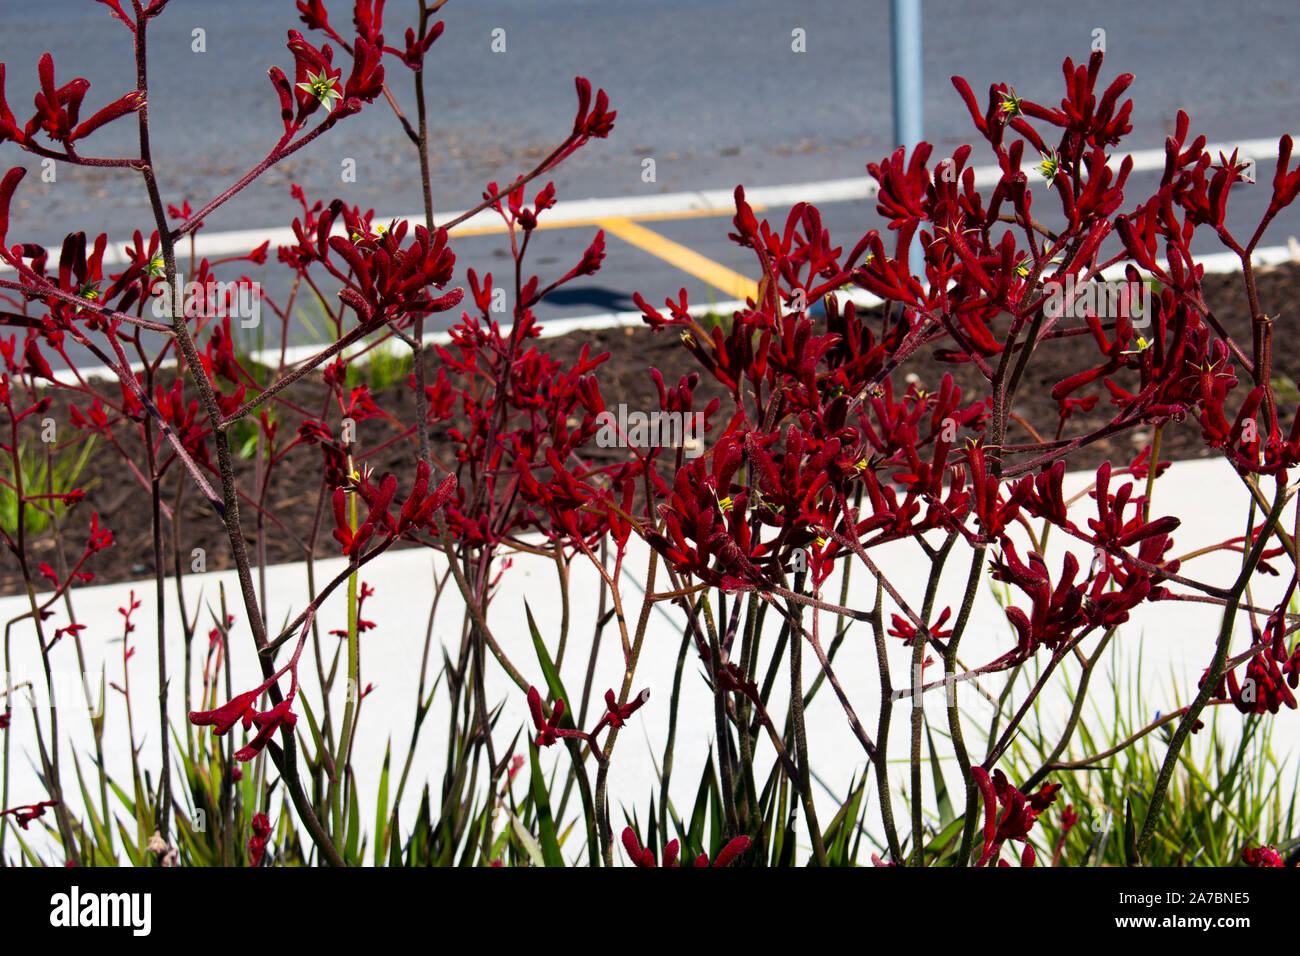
0, 0, 1300, 358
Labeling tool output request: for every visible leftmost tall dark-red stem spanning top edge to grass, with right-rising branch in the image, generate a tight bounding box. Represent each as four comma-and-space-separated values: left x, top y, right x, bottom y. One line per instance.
126, 0, 345, 866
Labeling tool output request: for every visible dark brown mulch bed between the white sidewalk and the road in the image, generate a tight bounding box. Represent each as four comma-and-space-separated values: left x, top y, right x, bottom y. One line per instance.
0, 257, 1300, 594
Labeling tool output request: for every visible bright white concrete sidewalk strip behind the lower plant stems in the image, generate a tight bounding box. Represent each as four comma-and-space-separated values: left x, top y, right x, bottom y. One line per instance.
0, 460, 1300, 856
